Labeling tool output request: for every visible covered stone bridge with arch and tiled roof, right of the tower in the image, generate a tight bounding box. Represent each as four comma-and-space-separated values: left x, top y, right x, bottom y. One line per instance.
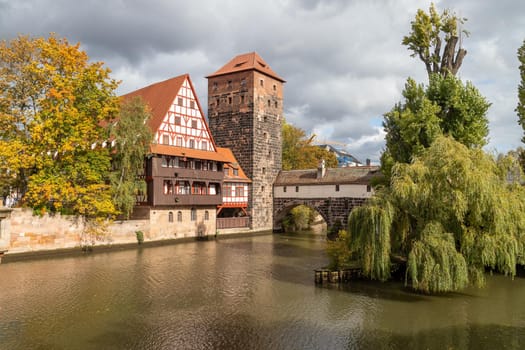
273, 165, 378, 231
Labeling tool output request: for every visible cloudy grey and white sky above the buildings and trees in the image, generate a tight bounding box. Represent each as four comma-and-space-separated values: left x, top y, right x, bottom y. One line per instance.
0, 0, 525, 161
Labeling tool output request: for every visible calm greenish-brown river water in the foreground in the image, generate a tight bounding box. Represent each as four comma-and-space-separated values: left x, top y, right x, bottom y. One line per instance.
0, 235, 525, 350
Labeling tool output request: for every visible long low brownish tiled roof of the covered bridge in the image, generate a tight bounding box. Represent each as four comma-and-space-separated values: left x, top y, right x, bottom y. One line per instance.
274, 166, 379, 186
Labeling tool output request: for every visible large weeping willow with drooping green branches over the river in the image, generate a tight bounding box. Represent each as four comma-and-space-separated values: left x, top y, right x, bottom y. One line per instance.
348, 137, 525, 293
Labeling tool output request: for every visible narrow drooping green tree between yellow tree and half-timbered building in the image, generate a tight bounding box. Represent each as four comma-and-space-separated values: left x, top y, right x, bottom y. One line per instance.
110, 97, 153, 218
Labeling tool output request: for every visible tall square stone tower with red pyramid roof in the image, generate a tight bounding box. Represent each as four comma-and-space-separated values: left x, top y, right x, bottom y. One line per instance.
207, 52, 285, 230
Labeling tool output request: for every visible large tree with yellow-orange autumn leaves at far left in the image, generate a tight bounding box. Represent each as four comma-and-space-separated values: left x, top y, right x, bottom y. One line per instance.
0, 35, 118, 217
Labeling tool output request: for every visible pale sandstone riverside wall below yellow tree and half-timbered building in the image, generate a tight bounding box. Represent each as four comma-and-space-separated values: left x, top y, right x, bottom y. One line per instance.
4, 207, 216, 254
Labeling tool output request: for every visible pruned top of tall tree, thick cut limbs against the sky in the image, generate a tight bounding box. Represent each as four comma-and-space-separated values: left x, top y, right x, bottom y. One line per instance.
402, 3, 468, 79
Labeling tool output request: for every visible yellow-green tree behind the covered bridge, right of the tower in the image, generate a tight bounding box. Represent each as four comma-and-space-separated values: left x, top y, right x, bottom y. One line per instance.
282, 121, 337, 170
